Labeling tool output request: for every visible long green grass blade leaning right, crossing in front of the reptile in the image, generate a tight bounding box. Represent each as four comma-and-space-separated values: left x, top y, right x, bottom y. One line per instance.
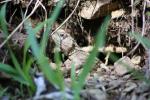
75, 16, 110, 98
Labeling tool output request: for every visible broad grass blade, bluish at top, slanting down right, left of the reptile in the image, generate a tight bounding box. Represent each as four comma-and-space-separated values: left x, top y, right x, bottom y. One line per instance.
25, 19, 63, 86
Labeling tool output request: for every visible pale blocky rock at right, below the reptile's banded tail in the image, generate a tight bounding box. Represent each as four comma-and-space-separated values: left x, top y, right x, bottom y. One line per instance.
114, 56, 135, 76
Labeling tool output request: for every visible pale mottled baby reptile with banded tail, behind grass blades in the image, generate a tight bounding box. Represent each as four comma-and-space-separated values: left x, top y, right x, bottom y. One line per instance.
52, 29, 127, 70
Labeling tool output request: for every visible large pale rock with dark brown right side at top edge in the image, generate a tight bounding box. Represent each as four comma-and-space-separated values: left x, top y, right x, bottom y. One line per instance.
78, 0, 121, 19
